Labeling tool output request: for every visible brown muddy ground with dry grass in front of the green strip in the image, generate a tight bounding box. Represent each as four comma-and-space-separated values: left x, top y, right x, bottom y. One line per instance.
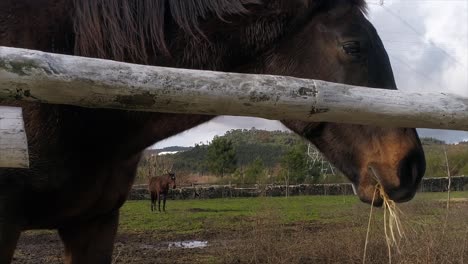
13, 217, 468, 264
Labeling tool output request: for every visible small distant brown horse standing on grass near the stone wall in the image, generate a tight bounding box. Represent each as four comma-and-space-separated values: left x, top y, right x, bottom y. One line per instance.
148, 172, 176, 212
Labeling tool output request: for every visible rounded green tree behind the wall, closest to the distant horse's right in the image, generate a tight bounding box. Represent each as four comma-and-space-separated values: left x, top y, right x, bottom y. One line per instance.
206, 137, 236, 177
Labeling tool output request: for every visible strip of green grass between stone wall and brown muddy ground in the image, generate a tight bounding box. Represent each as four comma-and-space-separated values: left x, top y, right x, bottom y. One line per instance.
120, 192, 468, 233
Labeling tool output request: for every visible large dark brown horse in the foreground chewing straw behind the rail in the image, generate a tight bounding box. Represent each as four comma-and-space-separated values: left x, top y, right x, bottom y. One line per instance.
0, 0, 425, 263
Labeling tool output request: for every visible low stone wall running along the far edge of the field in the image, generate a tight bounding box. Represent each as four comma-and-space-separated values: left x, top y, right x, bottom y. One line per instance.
129, 176, 468, 200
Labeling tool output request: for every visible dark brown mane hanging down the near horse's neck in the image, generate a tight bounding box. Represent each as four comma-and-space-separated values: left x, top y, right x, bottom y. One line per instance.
73, 0, 366, 63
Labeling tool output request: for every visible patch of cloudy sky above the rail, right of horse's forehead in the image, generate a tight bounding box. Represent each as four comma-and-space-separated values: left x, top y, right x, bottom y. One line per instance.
370, 0, 468, 96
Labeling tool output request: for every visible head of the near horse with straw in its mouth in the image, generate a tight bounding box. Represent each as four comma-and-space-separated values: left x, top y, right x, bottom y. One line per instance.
272, 0, 425, 205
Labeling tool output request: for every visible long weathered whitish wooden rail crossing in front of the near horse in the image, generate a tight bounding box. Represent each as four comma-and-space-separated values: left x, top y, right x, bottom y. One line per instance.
0, 47, 468, 167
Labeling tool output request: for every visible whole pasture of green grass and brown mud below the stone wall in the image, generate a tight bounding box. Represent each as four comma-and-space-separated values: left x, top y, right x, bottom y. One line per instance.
13, 192, 468, 263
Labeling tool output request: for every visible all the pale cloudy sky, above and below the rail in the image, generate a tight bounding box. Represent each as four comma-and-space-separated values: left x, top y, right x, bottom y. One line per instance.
154, 0, 468, 148
